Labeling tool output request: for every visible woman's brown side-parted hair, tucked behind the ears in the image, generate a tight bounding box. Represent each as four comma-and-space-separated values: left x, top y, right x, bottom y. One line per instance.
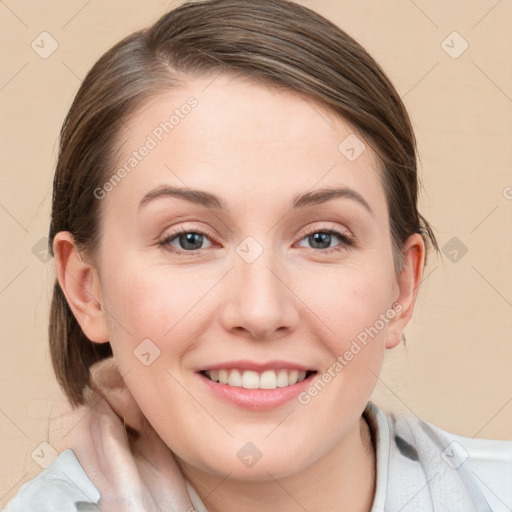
49, 0, 438, 406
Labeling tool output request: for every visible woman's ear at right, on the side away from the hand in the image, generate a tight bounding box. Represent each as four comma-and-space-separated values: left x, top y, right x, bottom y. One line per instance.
386, 233, 425, 348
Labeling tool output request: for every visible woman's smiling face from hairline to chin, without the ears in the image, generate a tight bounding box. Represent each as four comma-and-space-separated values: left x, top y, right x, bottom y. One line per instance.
84, 75, 412, 479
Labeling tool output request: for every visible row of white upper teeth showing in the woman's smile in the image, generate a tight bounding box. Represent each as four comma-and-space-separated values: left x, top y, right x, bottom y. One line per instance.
204, 369, 306, 389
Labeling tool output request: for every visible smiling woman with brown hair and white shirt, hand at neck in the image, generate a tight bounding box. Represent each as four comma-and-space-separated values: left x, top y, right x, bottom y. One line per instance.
6, 0, 511, 512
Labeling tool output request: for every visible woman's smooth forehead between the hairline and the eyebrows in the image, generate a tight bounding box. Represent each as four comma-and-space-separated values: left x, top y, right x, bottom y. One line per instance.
110, 74, 385, 214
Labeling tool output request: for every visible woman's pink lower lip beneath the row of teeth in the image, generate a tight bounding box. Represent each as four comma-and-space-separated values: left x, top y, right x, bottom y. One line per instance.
197, 373, 315, 411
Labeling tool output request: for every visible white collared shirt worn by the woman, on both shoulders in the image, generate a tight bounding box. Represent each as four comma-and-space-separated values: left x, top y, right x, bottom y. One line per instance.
4, 402, 512, 512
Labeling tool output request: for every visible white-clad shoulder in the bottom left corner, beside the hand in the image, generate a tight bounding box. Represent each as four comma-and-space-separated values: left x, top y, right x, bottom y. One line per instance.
3, 450, 100, 512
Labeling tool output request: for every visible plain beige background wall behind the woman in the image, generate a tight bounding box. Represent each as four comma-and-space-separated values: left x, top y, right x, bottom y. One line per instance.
0, 0, 512, 502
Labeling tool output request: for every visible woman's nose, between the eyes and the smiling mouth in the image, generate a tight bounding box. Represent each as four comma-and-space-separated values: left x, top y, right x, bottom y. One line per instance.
220, 250, 300, 340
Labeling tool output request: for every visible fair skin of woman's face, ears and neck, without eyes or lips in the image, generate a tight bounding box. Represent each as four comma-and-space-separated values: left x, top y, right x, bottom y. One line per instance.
54, 75, 424, 512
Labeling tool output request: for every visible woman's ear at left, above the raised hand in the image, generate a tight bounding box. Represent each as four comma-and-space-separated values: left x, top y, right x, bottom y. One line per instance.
53, 231, 109, 343
